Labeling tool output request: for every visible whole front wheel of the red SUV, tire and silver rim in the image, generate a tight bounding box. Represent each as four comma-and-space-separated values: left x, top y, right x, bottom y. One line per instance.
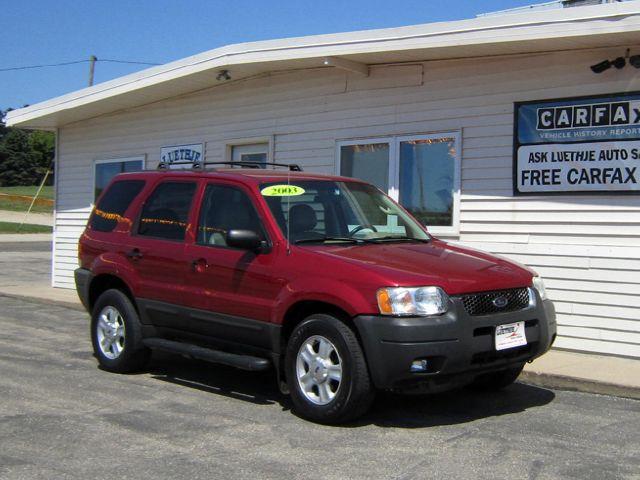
285, 314, 374, 424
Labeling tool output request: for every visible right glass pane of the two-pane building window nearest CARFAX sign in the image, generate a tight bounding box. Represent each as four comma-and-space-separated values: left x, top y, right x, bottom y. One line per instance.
399, 137, 456, 226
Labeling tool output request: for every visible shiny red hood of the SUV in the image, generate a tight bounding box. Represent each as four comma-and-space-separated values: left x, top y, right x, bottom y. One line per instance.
302, 239, 536, 295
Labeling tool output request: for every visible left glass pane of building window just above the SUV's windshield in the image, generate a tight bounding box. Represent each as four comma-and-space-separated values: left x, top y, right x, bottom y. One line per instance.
340, 143, 389, 192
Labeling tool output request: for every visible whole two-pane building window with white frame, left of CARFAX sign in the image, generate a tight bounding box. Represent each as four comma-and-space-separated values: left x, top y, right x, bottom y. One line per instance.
338, 132, 460, 235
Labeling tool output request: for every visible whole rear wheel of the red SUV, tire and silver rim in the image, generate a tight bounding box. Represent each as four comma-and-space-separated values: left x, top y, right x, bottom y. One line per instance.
91, 289, 151, 373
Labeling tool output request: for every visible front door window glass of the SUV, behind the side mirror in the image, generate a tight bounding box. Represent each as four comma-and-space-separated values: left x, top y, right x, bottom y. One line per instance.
197, 185, 265, 247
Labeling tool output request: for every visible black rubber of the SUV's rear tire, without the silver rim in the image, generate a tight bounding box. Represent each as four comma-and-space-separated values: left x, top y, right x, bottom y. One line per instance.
91, 289, 151, 373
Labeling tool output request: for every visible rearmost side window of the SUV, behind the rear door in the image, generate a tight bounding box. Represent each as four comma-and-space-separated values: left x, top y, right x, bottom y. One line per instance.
89, 180, 144, 232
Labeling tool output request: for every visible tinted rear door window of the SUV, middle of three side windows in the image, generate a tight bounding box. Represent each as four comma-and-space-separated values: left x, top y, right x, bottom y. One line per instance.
138, 182, 196, 241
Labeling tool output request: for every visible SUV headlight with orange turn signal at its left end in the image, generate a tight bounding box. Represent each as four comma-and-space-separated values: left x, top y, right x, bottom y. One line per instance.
376, 287, 449, 315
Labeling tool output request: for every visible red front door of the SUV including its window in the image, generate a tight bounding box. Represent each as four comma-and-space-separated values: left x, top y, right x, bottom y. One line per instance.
180, 182, 284, 346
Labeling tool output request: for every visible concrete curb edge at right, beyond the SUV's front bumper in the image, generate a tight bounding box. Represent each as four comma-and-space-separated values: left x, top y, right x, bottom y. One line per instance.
518, 371, 640, 400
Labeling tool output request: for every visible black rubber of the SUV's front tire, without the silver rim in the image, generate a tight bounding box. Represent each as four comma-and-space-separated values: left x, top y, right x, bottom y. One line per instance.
285, 314, 375, 424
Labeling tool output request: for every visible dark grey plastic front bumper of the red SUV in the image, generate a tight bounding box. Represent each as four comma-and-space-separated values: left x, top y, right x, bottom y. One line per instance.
354, 289, 556, 391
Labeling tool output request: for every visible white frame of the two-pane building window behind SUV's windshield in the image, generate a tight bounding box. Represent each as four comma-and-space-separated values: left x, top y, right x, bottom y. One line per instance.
335, 130, 462, 236
